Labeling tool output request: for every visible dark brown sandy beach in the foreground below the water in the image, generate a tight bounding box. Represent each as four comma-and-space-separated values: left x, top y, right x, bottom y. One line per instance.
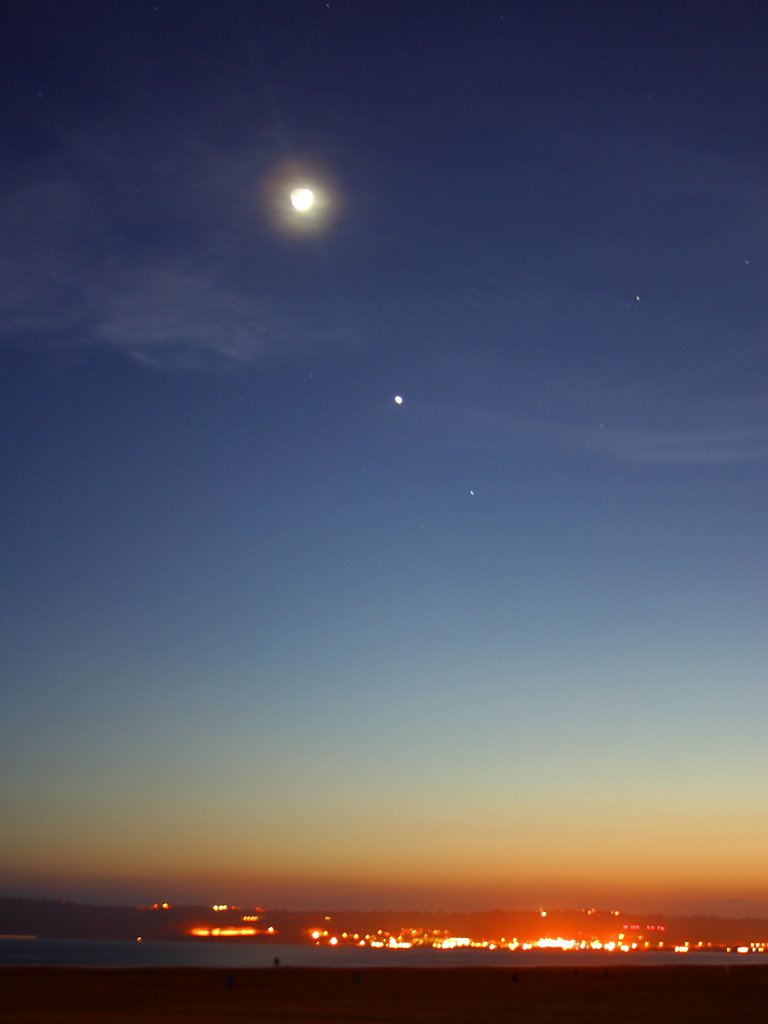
0, 965, 768, 1024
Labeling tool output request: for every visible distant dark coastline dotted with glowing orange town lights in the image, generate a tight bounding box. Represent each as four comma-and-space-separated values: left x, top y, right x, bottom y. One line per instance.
0, 897, 768, 955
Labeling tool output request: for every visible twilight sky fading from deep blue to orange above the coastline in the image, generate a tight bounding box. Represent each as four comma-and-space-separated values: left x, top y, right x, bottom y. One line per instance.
0, 0, 768, 913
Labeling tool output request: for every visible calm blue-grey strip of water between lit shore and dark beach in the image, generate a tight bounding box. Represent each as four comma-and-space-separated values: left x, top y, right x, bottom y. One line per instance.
0, 939, 768, 968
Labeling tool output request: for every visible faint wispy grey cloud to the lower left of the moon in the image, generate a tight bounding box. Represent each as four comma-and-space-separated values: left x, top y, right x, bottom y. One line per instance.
3, 245, 355, 369
